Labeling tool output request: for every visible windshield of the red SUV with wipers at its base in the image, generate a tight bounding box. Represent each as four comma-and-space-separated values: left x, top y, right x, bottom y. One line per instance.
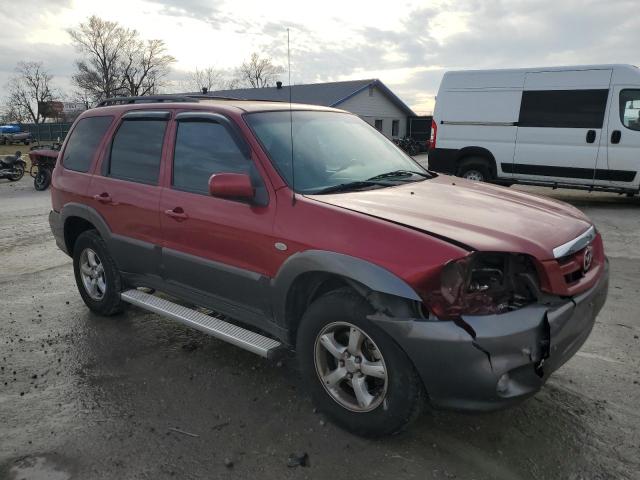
246, 111, 430, 193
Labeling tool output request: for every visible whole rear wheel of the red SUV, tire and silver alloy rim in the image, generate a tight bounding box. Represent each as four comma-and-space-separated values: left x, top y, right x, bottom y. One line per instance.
73, 230, 124, 317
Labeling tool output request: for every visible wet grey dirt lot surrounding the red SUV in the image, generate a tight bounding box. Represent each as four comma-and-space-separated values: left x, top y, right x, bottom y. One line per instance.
0, 162, 640, 480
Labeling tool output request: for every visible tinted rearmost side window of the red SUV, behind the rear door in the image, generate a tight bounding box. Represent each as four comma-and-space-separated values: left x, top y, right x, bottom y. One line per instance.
62, 117, 113, 172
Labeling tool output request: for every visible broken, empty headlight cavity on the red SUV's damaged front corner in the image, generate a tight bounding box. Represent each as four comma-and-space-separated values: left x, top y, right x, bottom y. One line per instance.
424, 252, 538, 320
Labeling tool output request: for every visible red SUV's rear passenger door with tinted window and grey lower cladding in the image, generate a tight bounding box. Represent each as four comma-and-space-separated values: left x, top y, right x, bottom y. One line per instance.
88, 110, 170, 275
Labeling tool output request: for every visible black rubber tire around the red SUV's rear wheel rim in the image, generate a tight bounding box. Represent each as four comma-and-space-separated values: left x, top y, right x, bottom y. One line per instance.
73, 230, 125, 317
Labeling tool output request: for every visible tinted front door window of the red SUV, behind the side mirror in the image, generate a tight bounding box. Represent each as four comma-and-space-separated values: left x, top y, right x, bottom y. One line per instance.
173, 121, 251, 194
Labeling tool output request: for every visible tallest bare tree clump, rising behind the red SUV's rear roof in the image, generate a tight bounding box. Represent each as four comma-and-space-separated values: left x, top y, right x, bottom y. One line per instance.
68, 16, 175, 101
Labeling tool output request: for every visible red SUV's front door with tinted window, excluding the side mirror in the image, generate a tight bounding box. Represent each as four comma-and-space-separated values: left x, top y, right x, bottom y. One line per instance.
160, 113, 275, 315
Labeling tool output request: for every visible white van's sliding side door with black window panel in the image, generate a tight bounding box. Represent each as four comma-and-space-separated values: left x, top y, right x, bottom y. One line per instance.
510, 69, 611, 185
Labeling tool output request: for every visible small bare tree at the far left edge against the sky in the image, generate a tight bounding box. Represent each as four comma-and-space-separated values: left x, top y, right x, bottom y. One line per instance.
7, 62, 53, 123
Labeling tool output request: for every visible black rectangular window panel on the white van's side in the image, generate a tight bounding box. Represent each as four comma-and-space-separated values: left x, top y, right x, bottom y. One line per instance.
518, 90, 609, 128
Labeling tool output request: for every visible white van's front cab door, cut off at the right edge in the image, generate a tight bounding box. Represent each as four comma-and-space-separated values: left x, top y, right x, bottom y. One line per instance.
605, 85, 640, 189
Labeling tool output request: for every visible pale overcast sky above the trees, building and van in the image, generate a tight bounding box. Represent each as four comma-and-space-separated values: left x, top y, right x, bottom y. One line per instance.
0, 0, 640, 113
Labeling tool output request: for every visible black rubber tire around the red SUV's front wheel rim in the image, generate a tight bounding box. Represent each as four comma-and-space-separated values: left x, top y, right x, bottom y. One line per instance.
296, 289, 426, 437
